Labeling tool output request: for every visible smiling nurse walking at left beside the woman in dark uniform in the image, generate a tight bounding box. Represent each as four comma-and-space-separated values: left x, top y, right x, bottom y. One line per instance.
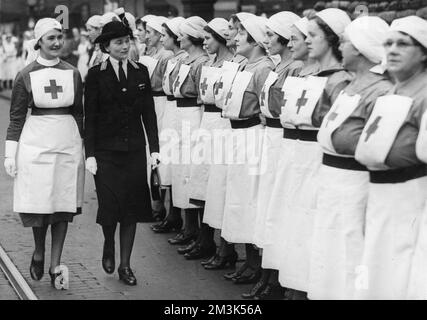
4, 18, 84, 289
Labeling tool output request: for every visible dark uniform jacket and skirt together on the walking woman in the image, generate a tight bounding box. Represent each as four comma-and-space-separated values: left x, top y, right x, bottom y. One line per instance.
85, 60, 159, 225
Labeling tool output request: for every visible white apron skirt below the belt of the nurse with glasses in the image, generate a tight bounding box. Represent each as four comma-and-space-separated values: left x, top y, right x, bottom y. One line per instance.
356, 177, 427, 300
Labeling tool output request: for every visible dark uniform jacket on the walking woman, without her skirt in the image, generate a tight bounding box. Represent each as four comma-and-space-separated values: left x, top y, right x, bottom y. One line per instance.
85, 59, 159, 158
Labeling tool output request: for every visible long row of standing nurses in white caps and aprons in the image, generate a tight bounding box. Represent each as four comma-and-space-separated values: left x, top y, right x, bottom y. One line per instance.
143, 9, 427, 299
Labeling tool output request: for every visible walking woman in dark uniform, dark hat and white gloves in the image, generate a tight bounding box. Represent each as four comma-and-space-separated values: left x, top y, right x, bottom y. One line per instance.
85, 21, 159, 285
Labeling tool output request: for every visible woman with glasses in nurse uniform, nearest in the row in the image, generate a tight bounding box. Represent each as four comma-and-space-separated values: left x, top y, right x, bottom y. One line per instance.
356, 16, 427, 299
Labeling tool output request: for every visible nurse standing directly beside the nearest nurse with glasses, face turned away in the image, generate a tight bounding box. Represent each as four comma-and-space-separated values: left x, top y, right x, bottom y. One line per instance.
308, 17, 392, 300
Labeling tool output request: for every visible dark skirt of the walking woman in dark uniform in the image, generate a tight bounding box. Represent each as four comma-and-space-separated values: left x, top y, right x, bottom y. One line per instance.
95, 148, 153, 226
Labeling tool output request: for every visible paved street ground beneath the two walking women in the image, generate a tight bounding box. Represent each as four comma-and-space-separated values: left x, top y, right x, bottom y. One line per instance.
0, 94, 249, 300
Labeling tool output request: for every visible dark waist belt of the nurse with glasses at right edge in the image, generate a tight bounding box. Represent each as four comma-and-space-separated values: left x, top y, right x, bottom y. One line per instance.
369, 164, 427, 184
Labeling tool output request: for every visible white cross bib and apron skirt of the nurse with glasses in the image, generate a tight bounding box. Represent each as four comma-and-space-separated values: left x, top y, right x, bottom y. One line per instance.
356, 95, 427, 299
